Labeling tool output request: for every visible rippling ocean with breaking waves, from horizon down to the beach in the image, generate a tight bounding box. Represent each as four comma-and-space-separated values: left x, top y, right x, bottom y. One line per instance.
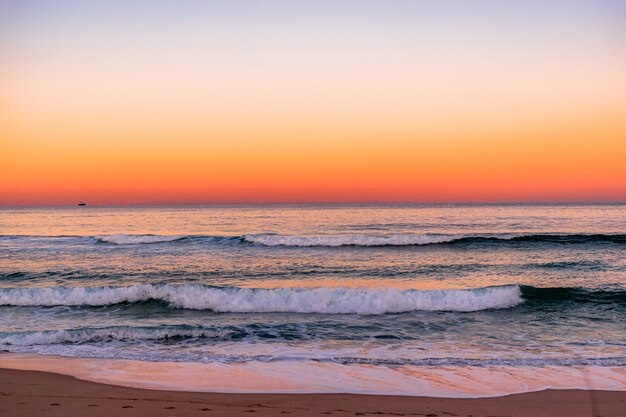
0, 204, 626, 397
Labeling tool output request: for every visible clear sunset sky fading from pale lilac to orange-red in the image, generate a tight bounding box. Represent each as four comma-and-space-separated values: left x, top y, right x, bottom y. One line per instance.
0, 0, 626, 205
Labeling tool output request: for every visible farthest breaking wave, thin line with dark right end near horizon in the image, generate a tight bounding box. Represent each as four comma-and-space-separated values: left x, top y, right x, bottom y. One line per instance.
0, 233, 626, 247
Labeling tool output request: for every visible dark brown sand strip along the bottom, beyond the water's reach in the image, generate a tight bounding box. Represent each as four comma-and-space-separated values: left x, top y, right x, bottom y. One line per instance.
0, 369, 626, 417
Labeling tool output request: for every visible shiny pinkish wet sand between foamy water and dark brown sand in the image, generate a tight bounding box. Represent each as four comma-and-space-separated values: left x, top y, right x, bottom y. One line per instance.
0, 352, 626, 398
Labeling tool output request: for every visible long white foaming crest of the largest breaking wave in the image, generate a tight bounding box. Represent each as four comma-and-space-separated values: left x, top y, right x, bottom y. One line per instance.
0, 284, 523, 315
